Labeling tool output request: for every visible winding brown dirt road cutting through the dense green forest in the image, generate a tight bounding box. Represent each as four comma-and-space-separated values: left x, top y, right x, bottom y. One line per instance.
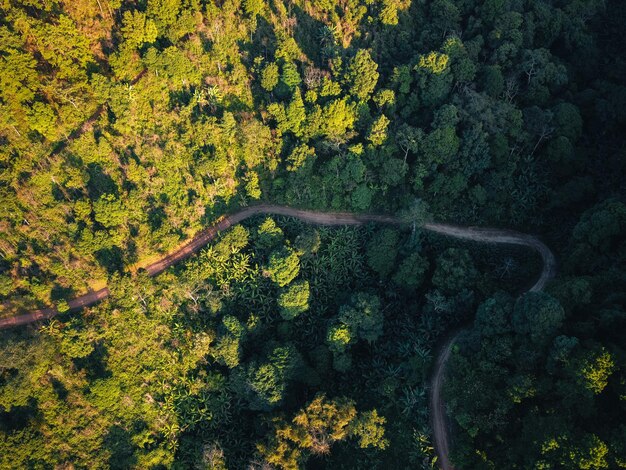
0, 204, 556, 470
